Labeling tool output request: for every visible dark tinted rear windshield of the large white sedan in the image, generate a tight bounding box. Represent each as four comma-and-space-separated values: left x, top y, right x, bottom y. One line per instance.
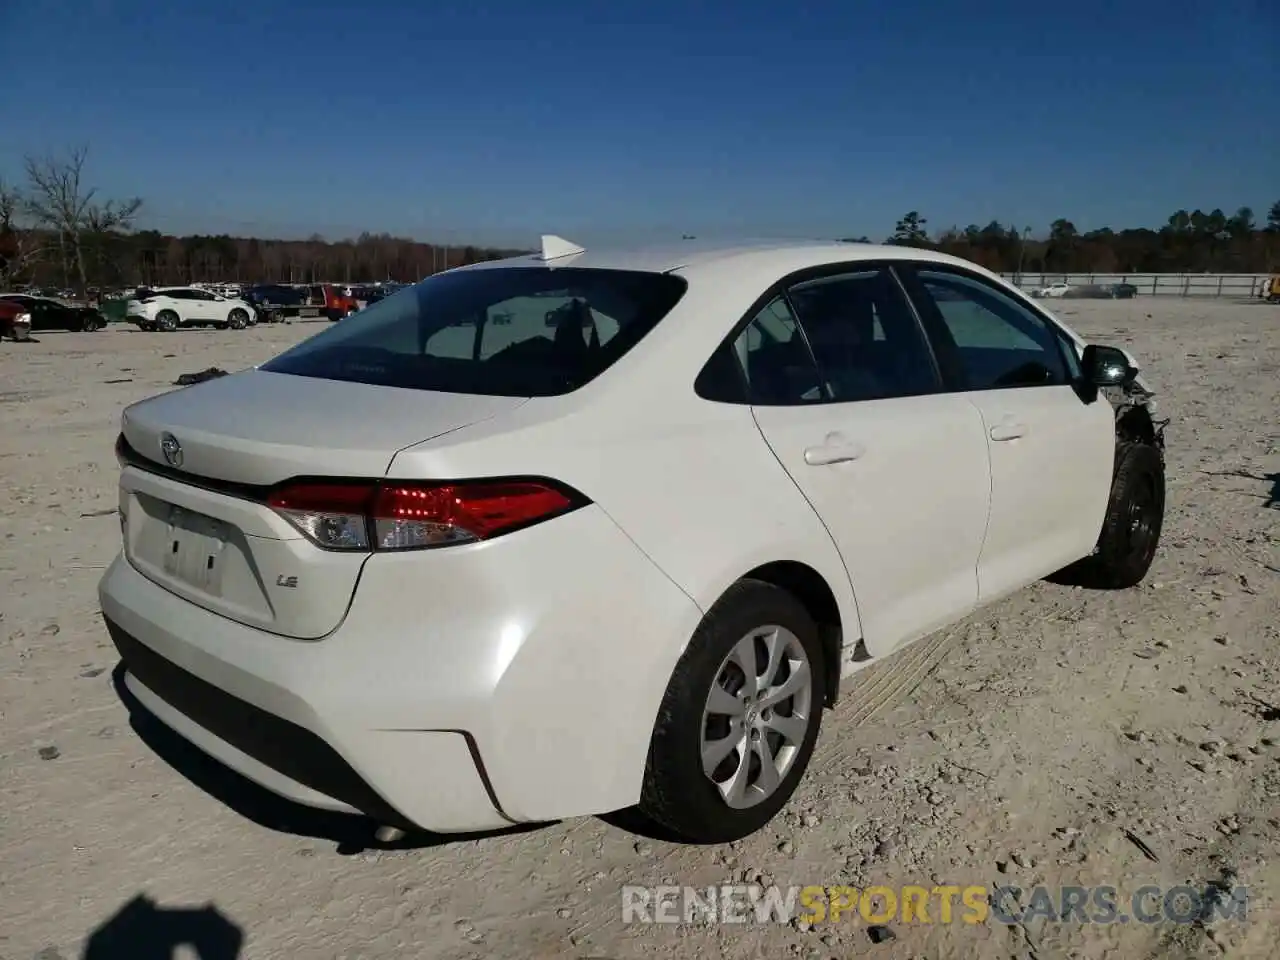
261, 268, 686, 397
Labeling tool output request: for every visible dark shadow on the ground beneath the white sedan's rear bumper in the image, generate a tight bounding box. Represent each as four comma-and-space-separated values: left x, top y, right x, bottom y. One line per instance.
111, 663, 553, 856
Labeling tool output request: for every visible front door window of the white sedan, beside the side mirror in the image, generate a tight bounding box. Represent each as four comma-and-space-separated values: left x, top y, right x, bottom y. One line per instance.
915, 269, 1068, 390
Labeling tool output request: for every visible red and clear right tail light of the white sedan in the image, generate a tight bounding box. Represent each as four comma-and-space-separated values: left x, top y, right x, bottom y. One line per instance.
268, 480, 588, 550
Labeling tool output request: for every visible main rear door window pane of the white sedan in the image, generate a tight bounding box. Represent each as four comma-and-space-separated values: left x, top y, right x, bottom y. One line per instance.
787, 268, 938, 402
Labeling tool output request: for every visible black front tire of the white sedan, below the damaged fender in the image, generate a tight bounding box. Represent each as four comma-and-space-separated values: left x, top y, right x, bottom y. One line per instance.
1087, 443, 1165, 590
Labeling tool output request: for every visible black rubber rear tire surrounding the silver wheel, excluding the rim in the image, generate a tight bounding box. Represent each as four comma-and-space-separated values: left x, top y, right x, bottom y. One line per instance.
640, 580, 826, 844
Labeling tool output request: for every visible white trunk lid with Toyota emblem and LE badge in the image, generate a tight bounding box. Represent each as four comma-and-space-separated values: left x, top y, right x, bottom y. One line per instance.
120, 370, 525, 640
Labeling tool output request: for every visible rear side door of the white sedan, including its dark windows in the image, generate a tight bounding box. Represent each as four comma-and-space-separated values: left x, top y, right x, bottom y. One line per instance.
735, 264, 991, 655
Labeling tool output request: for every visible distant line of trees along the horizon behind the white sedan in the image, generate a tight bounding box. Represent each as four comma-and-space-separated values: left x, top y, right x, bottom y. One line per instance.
0, 147, 1280, 291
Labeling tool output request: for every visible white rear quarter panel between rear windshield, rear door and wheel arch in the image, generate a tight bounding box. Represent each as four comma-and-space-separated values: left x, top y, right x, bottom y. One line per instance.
388, 259, 860, 666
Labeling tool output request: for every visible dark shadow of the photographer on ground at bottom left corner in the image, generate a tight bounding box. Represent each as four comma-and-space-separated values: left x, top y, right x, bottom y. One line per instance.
81, 893, 244, 960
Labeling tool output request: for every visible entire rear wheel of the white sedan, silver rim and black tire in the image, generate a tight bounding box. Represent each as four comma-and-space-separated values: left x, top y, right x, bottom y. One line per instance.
640, 580, 826, 844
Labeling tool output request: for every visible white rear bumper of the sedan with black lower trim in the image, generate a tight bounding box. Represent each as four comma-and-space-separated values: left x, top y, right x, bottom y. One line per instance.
100, 507, 701, 832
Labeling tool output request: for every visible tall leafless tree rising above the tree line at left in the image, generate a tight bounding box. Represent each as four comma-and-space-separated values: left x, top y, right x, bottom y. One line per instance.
27, 147, 142, 293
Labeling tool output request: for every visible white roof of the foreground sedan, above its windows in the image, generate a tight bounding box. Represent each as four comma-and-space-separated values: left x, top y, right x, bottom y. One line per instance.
458, 237, 973, 275
